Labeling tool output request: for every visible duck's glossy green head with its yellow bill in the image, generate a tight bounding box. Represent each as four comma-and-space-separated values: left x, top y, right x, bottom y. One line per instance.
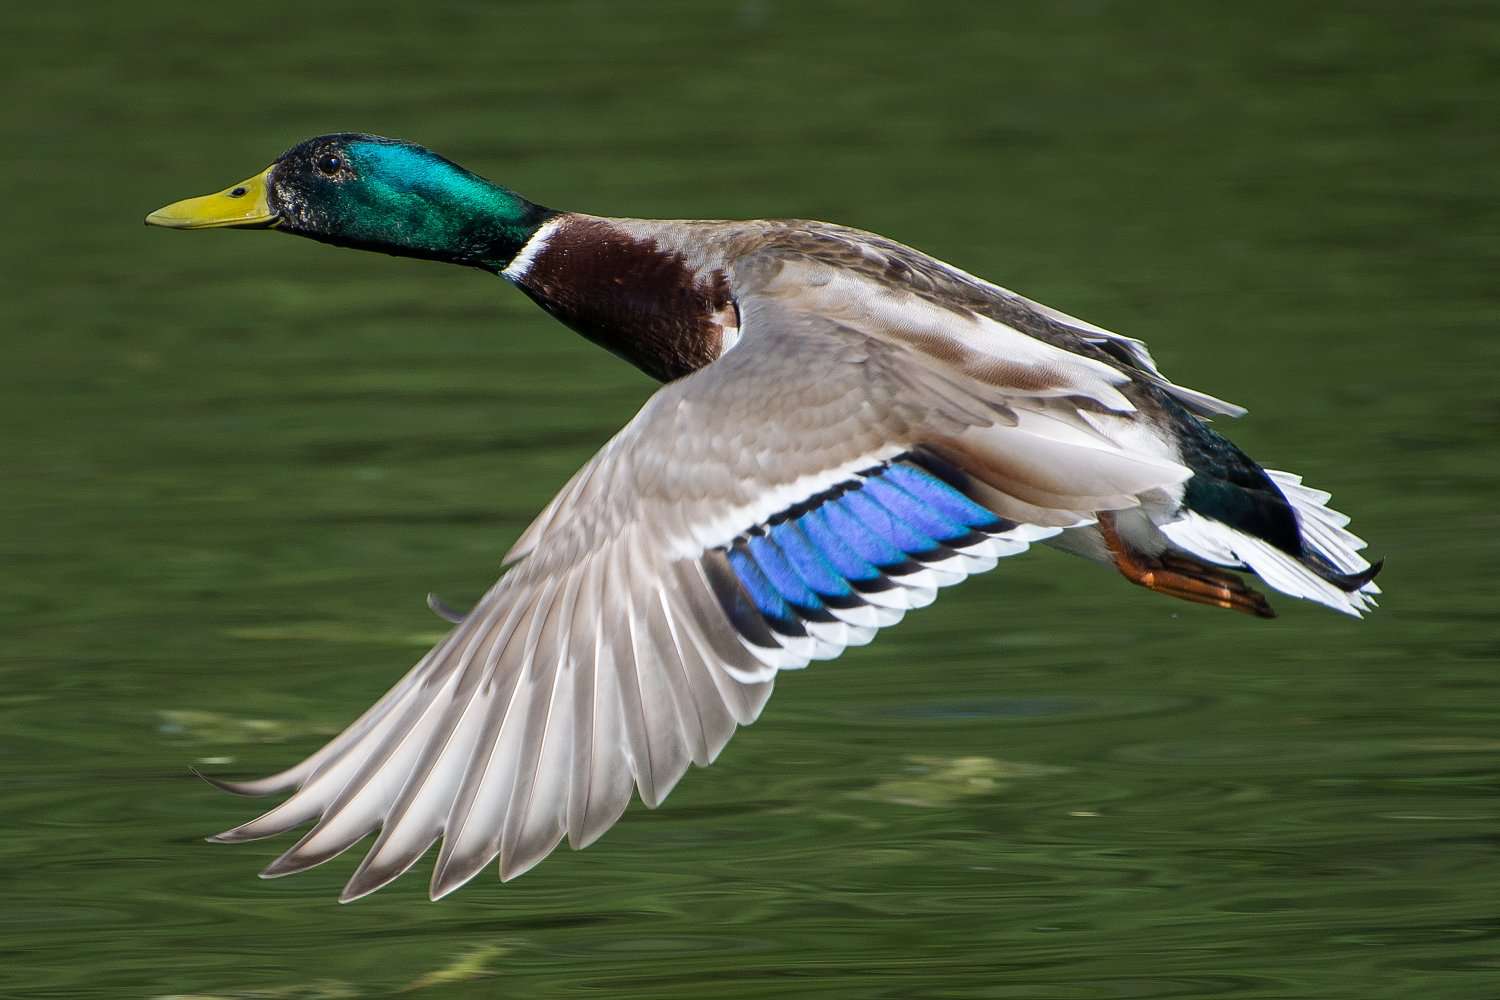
146, 132, 555, 270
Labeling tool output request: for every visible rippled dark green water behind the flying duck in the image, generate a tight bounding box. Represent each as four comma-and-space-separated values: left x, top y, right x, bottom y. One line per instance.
0, 0, 1500, 1000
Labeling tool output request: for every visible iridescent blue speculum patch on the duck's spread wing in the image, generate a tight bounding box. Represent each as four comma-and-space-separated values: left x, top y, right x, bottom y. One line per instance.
714, 456, 1011, 624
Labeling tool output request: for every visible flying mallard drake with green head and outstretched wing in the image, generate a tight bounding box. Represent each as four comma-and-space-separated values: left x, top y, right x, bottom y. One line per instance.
146, 133, 1380, 900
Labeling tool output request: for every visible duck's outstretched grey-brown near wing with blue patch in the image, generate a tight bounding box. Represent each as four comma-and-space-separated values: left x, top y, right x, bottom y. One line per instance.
205, 248, 1188, 900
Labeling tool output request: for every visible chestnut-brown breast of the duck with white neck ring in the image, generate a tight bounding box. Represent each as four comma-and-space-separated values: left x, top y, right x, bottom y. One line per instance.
501, 214, 740, 382
